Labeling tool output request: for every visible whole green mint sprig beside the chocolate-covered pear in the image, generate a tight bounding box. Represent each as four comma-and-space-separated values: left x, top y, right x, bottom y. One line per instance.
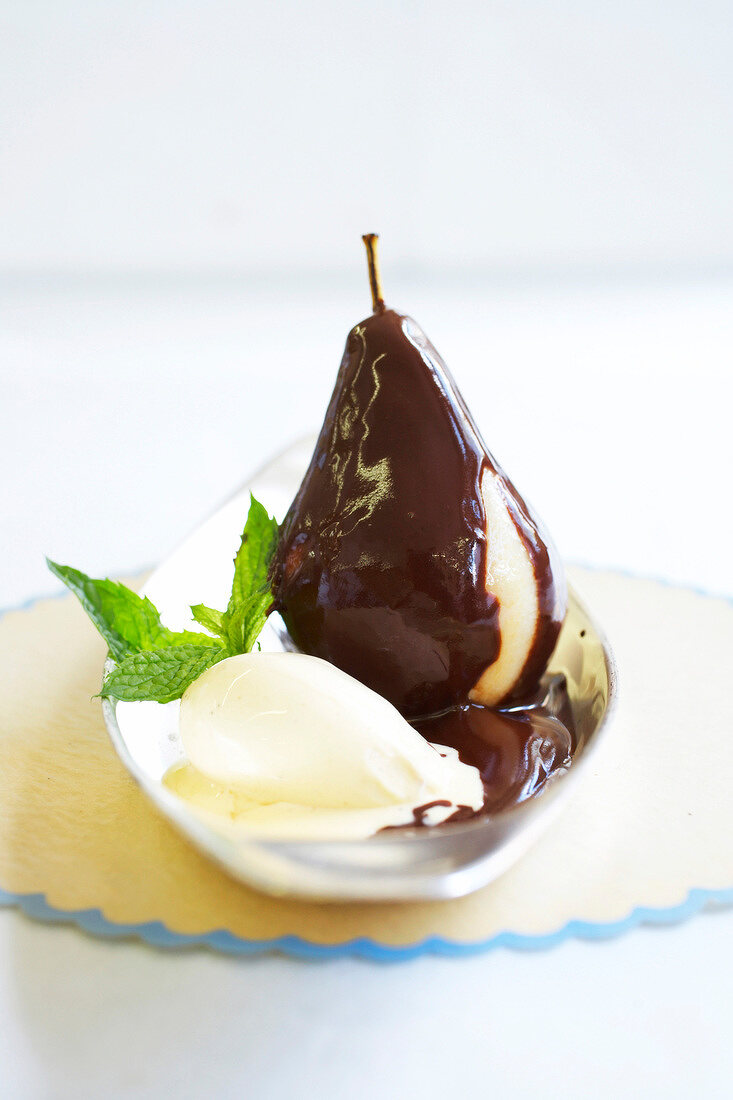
46, 496, 278, 703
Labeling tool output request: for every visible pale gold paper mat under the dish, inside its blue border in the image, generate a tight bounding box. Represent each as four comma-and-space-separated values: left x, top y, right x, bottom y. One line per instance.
0, 569, 733, 945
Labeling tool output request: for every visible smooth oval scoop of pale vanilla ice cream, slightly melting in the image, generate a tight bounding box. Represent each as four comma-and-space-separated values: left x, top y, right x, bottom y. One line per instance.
179, 653, 483, 811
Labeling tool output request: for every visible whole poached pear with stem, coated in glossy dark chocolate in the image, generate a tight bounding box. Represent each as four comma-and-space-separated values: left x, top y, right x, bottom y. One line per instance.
272, 234, 567, 718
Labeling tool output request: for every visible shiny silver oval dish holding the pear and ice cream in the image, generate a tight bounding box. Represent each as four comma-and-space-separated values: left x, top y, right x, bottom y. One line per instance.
102, 438, 615, 902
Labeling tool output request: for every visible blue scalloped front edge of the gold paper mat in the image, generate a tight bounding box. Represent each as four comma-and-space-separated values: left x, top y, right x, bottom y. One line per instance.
0, 888, 733, 963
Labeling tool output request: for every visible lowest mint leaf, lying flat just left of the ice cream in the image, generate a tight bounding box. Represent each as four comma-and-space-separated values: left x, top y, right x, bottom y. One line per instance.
101, 635, 227, 703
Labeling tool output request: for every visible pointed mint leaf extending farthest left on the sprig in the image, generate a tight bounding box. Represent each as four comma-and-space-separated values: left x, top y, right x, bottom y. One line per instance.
46, 558, 221, 661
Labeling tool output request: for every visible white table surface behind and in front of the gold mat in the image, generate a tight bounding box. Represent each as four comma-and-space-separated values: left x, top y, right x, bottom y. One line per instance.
0, 277, 733, 1100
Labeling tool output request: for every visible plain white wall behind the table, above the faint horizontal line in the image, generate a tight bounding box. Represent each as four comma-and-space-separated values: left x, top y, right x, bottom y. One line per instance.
0, 0, 733, 273
